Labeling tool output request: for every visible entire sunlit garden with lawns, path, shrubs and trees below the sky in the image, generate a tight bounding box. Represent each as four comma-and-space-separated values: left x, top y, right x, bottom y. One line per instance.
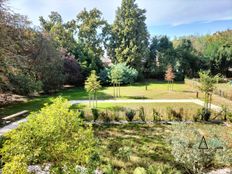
0, 0, 232, 174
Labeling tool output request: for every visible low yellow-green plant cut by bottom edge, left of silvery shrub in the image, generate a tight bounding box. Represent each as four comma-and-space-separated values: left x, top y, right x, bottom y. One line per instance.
147, 163, 181, 174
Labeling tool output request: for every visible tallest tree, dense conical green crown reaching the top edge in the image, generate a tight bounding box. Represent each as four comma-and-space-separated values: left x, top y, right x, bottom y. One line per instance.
109, 0, 149, 70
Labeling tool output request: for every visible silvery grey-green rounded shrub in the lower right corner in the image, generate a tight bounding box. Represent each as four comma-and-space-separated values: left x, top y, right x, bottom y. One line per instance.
169, 125, 232, 173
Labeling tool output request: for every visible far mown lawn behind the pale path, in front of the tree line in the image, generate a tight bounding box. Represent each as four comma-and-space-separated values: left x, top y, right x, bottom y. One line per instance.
0, 81, 232, 117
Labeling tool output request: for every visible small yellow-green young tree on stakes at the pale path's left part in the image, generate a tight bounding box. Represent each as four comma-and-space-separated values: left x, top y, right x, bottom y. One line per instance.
85, 70, 101, 107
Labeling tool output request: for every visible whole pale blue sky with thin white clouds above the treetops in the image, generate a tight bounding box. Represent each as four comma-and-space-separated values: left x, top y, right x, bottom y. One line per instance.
8, 0, 232, 38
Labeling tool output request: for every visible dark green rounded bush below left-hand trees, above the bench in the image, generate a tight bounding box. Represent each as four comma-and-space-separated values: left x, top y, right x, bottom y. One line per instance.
8, 74, 42, 95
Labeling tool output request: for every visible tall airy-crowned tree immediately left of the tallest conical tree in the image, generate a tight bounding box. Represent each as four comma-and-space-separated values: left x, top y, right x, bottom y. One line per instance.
76, 8, 107, 72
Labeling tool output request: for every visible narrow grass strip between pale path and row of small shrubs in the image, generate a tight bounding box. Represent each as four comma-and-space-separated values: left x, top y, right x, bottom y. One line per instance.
72, 103, 201, 121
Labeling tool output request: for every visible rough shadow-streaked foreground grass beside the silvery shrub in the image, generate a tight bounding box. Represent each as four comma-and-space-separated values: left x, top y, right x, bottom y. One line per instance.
94, 124, 232, 173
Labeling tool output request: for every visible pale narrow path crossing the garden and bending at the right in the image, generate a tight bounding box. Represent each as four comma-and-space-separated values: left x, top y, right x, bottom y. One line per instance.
0, 99, 222, 135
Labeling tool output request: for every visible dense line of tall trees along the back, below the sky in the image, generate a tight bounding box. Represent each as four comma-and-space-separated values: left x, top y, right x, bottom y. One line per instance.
0, 0, 232, 95
